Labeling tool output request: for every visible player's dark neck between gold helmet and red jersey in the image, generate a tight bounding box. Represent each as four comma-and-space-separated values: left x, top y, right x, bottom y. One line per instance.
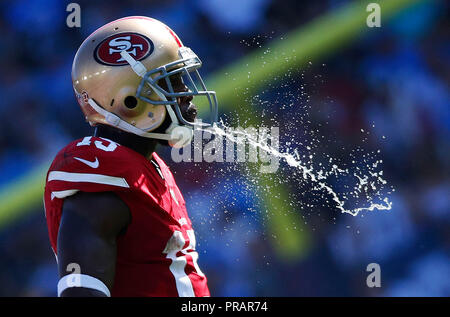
94, 125, 157, 158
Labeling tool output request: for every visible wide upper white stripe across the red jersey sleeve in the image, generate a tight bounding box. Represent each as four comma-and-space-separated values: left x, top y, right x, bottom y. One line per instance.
48, 171, 130, 188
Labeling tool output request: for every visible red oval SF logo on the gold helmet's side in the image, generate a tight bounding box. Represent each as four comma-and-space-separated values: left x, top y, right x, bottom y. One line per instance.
94, 32, 153, 66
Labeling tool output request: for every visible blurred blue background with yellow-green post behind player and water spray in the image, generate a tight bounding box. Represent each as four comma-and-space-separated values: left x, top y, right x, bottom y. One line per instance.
0, 0, 450, 296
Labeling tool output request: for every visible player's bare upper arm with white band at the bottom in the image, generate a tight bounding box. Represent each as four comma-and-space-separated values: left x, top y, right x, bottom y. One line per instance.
57, 192, 131, 297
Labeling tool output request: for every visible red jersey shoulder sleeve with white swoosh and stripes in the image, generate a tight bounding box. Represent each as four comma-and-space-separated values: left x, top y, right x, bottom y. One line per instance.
46, 137, 134, 200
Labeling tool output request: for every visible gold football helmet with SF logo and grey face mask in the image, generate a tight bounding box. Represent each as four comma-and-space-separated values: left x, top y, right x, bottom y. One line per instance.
72, 16, 217, 147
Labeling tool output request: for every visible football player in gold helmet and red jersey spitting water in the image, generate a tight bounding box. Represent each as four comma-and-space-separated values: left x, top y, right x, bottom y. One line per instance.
44, 16, 217, 297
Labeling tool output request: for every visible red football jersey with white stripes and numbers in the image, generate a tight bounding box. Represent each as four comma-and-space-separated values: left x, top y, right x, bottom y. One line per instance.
44, 137, 210, 297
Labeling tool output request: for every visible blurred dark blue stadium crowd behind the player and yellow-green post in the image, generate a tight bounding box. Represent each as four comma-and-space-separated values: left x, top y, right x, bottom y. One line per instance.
0, 0, 450, 296
